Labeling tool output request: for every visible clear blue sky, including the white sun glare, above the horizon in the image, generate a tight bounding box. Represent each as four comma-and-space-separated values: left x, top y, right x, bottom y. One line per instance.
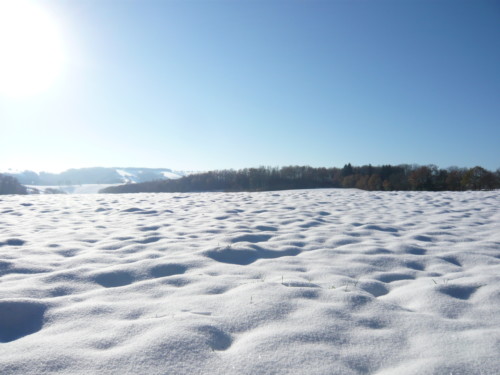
0, 0, 500, 172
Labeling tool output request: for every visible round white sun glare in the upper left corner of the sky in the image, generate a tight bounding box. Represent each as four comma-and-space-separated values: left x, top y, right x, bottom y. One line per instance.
0, 0, 64, 97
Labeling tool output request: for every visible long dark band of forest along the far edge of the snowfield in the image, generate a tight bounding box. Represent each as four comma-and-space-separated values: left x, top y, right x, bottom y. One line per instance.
100, 164, 500, 193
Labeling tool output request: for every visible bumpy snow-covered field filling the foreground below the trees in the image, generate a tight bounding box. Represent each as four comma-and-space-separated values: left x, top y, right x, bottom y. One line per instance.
0, 190, 500, 375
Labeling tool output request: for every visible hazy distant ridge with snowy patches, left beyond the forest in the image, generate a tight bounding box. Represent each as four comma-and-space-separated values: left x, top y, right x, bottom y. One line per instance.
4, 167, 188, 186
